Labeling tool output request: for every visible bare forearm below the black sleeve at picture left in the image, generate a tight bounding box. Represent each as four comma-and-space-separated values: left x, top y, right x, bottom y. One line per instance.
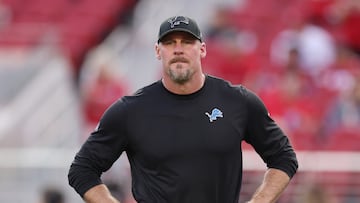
84, 184, 120, 203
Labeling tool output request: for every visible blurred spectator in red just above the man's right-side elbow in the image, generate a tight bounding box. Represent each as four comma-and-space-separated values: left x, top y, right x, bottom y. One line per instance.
257, 48, 321, 149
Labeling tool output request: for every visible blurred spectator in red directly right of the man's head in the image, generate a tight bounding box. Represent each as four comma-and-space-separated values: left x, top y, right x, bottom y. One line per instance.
203, 6, 258, 84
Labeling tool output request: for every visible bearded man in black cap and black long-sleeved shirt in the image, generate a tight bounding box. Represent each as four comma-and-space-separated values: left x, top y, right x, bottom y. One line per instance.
69, 16, 298, 203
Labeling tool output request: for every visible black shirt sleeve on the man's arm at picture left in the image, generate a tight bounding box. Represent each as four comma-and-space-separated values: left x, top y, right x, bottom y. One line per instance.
68, 100, 127, 197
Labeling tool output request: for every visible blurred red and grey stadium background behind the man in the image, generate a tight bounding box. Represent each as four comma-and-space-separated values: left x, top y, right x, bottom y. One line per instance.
0, 0, 360, 203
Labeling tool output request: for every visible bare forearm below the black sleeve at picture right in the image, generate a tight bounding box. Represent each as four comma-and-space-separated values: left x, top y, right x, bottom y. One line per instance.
247, 168, 290, 203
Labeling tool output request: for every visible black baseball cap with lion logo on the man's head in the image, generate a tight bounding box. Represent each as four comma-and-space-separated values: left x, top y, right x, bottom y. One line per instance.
158, 16, 202, 42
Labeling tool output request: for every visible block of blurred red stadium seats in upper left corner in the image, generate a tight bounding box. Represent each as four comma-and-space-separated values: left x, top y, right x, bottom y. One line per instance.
0, 0, 136, 74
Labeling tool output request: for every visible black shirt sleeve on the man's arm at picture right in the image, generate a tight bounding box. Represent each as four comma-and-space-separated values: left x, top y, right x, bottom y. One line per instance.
245, 87, 298, 178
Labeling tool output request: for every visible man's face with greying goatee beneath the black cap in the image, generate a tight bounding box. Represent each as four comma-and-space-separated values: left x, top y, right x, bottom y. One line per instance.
155, 32, 206, 84
